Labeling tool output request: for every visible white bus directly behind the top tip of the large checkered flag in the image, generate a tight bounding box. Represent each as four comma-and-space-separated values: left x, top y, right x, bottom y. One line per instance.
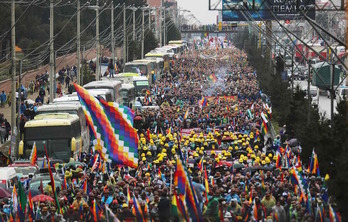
83, 80, 123, 104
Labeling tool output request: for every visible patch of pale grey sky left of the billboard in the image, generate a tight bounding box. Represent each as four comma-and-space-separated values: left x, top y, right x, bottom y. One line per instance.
176, 0, 218, 25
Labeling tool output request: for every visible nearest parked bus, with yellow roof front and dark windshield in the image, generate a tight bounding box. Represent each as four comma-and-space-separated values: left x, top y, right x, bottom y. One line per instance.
18, 113, 90, 162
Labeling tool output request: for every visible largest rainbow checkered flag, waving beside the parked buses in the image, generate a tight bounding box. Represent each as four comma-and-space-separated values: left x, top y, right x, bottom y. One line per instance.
74, 84, 138, 168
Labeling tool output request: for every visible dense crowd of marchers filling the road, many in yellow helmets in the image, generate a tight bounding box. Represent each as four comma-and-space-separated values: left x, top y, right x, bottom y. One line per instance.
1, 43, 342, 222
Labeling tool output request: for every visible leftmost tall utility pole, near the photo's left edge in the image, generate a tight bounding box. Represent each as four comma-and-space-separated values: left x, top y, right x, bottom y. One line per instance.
11, 0, 16, 142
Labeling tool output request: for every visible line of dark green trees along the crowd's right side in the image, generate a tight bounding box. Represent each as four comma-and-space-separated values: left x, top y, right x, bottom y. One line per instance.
234, 27, 348, 221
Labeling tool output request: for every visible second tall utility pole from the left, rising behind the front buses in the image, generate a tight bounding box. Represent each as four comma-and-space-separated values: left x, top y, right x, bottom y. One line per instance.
49, 0, 55, 103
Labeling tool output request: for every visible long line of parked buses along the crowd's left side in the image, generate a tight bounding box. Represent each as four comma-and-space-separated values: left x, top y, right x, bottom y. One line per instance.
12, 40, 187, 163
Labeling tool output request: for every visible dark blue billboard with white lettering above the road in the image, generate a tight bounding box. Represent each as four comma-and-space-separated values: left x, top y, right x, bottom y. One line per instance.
222, 0, 315, 21
